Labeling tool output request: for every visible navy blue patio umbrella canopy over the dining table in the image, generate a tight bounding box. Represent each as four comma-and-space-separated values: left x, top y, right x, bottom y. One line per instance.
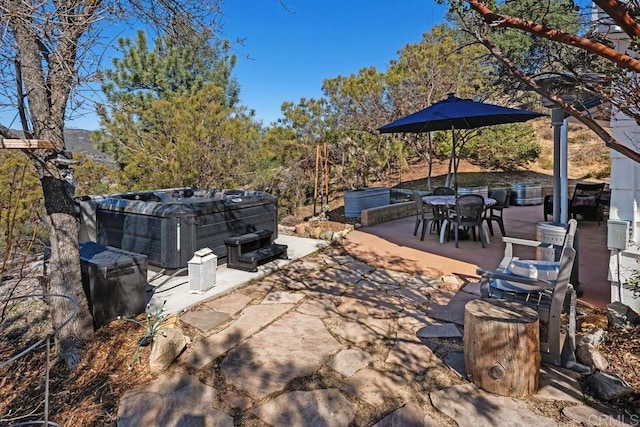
378, 94, 546, 133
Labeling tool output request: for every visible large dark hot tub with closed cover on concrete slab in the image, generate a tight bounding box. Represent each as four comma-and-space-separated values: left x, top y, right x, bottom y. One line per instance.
80, 188, 278, 269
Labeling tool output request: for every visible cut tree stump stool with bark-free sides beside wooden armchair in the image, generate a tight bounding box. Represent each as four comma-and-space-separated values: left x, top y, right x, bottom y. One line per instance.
463, 300, 540, 398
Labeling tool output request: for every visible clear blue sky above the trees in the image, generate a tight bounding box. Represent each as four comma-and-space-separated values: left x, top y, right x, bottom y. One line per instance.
62, 0, 446, 129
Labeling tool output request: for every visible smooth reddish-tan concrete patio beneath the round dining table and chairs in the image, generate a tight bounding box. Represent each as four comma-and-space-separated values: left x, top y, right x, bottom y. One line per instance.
344, 205, 610, 308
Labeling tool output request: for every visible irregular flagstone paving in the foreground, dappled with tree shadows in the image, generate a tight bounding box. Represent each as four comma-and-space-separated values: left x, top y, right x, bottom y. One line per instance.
118, 248, 614, 427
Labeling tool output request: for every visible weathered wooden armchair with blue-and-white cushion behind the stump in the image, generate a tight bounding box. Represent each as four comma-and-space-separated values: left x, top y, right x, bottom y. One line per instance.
477, 219, 589, 373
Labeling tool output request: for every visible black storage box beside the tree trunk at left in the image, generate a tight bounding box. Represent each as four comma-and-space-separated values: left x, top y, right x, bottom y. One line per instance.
80, 242, 147, 328
